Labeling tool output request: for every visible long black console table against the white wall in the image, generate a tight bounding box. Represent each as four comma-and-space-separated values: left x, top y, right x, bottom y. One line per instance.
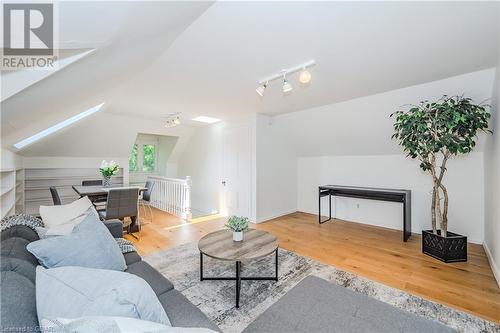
318, 185, 411, 242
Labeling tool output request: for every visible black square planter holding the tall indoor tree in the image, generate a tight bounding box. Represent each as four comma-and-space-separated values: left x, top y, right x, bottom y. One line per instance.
422, 230, 467, 262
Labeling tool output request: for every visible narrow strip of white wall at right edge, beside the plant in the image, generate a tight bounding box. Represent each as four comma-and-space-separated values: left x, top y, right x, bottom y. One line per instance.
483, 61, 500, 286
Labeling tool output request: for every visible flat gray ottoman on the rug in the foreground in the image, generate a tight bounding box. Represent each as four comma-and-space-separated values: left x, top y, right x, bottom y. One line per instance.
243, 276, 455, 333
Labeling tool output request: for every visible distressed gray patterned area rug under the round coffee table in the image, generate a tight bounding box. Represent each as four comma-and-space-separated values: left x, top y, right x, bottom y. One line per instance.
144, 242, 500, 333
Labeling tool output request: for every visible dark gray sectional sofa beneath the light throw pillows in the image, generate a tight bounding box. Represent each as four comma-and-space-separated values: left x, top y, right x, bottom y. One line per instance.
0, 221, 219, 332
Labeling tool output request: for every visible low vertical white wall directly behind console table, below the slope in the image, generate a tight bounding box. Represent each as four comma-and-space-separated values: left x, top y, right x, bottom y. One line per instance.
297, 152, 484, 243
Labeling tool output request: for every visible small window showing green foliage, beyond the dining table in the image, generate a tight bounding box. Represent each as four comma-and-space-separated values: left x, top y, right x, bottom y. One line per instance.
128, 140, 158, 173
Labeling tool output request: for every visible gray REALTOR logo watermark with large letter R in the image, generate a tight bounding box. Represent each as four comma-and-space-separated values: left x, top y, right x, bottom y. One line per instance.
1, 2, 58, 70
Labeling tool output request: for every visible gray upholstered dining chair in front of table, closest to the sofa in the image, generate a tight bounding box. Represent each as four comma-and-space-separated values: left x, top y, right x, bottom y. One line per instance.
99, 188, 141, 238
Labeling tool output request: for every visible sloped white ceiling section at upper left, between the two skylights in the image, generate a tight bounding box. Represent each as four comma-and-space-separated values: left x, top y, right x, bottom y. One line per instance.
1, 2, 211, 156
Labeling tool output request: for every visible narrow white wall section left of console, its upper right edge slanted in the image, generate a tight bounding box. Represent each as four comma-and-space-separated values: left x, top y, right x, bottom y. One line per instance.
256, 114, 297, 222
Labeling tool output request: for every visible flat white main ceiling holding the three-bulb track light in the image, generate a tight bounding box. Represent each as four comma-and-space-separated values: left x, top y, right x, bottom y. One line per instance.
112, 2, 498, 119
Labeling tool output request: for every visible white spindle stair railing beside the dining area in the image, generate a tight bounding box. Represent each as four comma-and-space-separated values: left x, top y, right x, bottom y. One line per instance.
148, 176, 192, 220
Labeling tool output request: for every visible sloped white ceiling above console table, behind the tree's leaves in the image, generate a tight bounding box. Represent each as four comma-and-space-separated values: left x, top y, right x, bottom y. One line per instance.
271, 68, 496, 157
